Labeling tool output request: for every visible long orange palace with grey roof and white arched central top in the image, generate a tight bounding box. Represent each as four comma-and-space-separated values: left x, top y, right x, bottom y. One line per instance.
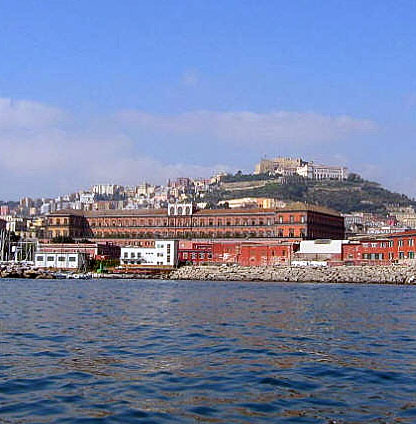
46, 204, 344, 244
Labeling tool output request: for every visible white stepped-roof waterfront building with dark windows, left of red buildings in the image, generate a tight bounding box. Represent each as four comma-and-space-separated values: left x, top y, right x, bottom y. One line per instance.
120, 240, 178, 267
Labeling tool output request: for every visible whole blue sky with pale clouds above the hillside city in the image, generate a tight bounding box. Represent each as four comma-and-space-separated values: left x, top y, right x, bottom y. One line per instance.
0, 0, 416, 199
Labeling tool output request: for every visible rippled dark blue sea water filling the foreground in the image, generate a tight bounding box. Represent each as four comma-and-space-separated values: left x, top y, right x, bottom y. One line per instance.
0, 280, 416, 423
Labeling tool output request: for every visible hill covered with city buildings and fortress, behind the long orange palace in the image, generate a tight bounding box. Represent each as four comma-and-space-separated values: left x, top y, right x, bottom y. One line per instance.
0, 157, 416, 248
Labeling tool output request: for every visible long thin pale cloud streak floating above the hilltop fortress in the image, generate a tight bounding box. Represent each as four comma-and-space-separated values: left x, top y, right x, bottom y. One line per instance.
116, 110, 376, 146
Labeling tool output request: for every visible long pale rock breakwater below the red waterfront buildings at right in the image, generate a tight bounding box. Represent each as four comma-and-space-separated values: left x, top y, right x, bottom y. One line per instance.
169, 265, 416, 284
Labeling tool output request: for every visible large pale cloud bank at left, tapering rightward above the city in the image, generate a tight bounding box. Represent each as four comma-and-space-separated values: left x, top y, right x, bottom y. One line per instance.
0, 99, 231, 199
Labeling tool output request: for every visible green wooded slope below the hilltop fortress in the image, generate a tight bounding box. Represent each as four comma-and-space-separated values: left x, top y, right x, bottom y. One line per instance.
204, 174, 416, 214
